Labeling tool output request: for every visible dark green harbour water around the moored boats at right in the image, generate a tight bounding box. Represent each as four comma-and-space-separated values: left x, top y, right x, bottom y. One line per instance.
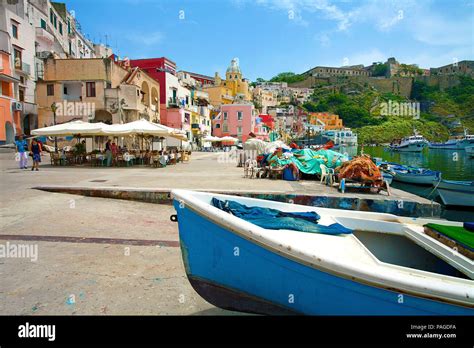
362, 146, 474, 221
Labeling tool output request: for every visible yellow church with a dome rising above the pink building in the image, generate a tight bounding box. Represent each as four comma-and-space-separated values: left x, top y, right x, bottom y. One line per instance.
204, 58, 252, 106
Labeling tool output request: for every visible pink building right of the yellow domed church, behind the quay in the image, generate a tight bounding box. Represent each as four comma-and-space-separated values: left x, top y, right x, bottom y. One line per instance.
212, 104, 268, 143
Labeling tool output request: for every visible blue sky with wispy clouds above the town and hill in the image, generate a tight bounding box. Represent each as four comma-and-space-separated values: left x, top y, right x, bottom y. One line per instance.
64, 0, 474, 81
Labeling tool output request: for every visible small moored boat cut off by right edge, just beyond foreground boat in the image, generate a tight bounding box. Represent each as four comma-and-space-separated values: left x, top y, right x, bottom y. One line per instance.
433, 180, 474, 207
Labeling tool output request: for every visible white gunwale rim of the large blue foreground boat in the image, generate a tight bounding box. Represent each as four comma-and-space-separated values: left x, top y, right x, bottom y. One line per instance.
171, 190, 474, 308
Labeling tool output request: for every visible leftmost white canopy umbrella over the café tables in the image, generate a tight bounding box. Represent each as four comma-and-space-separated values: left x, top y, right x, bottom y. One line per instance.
31, 121, 107, 137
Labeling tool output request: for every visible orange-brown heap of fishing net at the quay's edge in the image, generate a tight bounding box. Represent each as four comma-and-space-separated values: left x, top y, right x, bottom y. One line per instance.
336, 155, 383, 187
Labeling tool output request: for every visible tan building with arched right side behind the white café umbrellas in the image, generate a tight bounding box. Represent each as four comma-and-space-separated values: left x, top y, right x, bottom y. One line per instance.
36, 58, 160, 127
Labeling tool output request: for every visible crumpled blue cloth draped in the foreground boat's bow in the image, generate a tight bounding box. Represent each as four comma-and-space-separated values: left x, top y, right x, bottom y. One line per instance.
212, 198, 352, 235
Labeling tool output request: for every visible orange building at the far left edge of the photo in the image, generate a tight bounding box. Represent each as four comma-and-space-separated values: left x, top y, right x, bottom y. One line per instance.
0, 31, 21, 144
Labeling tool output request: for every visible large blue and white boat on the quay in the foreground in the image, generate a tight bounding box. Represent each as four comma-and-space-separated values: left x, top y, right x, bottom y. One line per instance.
171, 190, 474, 315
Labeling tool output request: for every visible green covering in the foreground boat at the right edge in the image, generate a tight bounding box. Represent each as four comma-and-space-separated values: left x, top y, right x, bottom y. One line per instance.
424, 224, 474, 260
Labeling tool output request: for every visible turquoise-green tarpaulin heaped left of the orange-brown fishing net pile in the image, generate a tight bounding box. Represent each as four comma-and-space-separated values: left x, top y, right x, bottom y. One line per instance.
268, 149, 347, 174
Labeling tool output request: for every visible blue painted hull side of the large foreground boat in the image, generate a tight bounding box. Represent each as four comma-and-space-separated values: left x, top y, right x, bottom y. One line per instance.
174, 201, 474, 315
